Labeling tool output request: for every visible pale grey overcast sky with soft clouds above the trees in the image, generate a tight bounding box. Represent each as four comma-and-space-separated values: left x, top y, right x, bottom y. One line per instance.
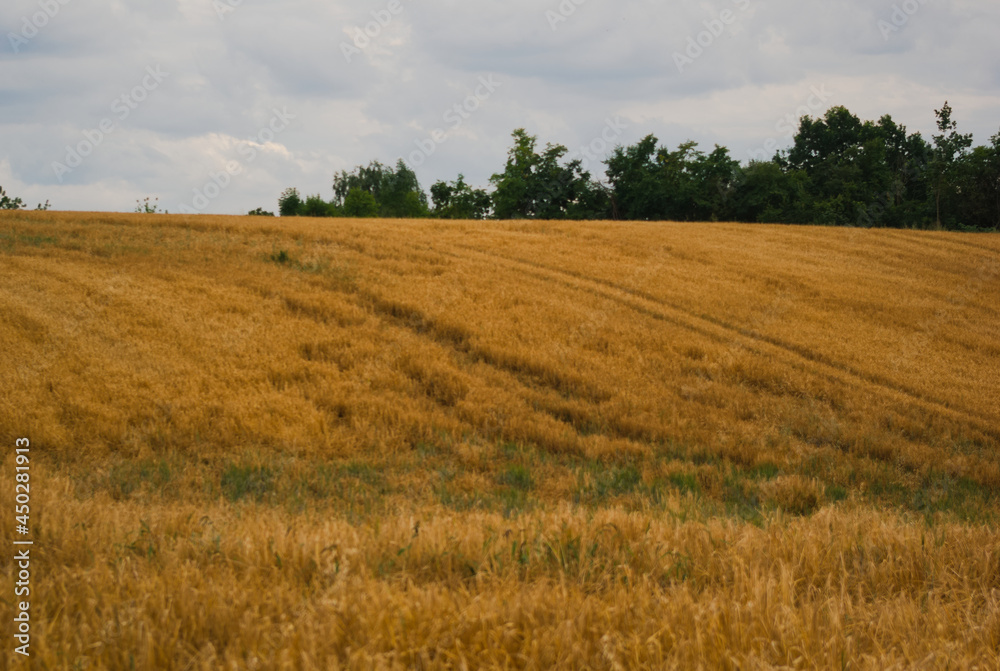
0, 0, 1000, 214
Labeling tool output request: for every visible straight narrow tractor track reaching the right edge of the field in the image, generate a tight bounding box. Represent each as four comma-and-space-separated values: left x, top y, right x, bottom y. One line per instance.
452, 244, 1000, 440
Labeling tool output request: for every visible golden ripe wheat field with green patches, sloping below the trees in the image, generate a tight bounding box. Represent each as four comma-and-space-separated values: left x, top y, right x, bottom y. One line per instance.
0, 212, 1000, 670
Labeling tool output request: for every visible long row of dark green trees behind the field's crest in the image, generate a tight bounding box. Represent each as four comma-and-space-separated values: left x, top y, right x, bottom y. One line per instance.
274, 102, 1000, 230
